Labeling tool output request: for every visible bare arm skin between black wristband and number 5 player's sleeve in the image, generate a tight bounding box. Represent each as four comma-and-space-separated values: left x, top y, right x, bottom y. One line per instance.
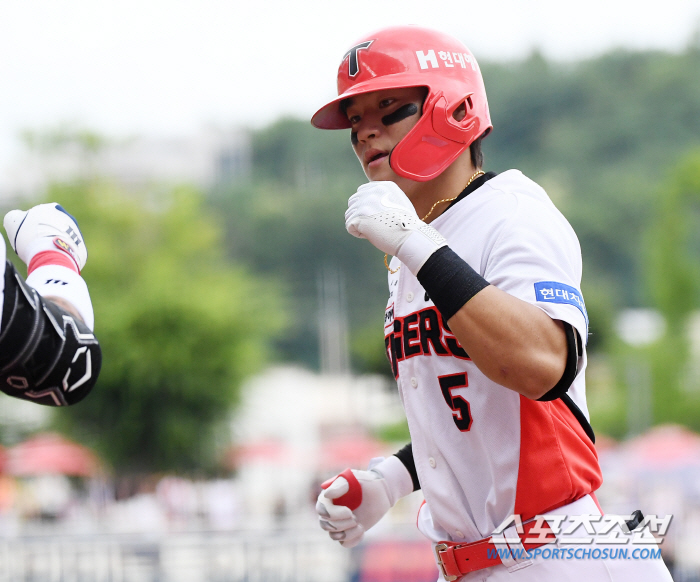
448, 285, 567, 399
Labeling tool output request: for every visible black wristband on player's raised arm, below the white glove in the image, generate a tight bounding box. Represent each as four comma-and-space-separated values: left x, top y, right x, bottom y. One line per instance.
418, 247, 489, 321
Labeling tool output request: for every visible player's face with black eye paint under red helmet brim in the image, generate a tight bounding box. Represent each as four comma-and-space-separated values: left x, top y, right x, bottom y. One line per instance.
345, 87, 427, 182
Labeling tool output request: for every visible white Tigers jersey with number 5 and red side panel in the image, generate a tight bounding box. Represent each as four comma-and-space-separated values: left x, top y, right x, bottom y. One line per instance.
384, 170, 602, 542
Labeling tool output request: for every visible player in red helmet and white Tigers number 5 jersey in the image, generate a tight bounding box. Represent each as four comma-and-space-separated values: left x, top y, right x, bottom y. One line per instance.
312, 27, 670, 582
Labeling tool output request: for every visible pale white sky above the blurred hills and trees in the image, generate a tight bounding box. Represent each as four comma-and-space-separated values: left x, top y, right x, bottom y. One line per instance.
0, 0, 700, 172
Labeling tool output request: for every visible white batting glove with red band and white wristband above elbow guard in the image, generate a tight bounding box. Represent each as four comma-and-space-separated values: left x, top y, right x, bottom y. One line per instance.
3, 202, 95, 330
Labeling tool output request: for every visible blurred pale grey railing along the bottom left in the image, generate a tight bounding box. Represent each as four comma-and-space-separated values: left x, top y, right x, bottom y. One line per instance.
0, 531, 351, 582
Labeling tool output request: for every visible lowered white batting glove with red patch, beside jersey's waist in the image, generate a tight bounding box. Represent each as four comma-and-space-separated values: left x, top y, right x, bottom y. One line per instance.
316, 455, 413, 548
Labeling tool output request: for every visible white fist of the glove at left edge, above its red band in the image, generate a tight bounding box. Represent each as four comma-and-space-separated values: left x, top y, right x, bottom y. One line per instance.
3, 202, 87, 271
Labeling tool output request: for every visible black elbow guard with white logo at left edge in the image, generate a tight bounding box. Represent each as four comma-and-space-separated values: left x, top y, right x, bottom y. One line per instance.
0, 261, 102, 406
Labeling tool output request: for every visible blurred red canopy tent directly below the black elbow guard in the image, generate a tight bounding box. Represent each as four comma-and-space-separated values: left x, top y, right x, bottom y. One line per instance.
5, 433, 100, 477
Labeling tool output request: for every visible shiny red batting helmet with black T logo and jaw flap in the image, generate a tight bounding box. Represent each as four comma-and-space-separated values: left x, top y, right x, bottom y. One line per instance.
311, 26, 492, 182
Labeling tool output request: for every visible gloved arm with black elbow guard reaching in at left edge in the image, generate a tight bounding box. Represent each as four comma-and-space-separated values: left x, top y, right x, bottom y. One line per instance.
0, 203, 102, 406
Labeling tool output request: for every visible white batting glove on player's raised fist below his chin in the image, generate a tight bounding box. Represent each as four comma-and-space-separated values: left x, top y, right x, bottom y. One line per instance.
345, 182, 447, 275
